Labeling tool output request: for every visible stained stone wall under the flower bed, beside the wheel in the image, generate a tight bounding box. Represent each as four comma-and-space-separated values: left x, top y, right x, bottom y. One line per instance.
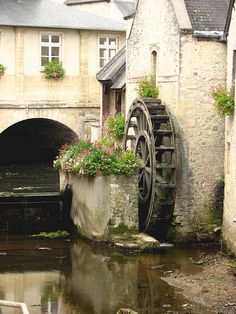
60, 174, 138, 240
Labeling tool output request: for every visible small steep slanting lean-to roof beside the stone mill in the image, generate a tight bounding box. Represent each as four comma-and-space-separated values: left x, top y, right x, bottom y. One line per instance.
97, 47, 126, 84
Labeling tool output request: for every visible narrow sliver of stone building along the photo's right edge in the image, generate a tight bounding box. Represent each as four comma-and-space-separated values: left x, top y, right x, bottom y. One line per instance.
223, 0, 236, 253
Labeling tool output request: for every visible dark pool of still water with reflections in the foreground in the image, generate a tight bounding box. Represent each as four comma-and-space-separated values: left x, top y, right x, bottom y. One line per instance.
0, 234, 217, 314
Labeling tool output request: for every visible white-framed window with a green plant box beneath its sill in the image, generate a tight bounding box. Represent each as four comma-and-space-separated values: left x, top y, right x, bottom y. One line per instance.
40, 34, 61, 67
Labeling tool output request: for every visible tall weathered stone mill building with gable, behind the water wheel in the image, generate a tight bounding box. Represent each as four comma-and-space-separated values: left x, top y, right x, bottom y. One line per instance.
126, 0, 229, 240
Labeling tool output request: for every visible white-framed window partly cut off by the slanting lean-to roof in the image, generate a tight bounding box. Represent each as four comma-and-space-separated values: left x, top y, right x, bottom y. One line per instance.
99, 37, 118, 68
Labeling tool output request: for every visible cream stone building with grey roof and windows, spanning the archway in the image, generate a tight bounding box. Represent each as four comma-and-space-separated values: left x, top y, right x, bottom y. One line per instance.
0, 0, 125, 153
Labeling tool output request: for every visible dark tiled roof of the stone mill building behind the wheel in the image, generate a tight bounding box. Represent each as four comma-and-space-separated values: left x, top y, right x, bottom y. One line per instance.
184, 0, 230, 31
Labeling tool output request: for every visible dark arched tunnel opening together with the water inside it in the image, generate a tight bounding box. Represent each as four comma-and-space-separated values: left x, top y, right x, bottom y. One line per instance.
0, 118, 77, 193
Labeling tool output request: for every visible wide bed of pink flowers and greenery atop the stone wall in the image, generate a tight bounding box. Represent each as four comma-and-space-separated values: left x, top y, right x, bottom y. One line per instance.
54, 139, 140, 177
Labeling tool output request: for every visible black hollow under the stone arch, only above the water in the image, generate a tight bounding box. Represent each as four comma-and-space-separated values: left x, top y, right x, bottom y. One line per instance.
0, 118, 77, 164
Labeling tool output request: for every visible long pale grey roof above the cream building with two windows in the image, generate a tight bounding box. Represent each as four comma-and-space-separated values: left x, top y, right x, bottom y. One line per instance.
0, 0, 125, 31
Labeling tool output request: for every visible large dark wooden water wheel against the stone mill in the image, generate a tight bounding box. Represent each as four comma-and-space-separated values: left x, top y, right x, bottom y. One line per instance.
124, 98, 176, 235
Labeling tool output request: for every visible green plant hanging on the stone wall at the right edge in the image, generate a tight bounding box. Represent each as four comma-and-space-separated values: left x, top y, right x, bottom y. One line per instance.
212, 86, 234, 116
